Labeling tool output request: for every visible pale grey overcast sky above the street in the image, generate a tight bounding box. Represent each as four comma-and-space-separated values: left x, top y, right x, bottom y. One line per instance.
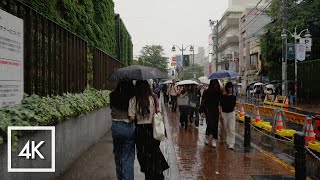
114, 0, 228, 56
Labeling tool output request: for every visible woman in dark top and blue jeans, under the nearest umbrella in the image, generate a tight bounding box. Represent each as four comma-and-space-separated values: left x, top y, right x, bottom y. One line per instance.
110, 81, 135, 180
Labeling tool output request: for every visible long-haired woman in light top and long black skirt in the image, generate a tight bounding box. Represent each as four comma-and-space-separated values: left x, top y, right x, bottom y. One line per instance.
128, 80, 169, 180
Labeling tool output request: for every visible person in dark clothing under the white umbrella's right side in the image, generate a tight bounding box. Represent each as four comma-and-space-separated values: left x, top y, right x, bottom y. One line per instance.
189, 85, 201, 128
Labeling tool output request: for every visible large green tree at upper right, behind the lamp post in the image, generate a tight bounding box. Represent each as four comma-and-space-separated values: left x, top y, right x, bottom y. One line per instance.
260, 0, 320, 80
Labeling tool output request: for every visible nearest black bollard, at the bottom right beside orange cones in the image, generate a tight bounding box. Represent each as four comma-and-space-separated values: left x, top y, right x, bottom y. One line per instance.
294, 132, 306, 180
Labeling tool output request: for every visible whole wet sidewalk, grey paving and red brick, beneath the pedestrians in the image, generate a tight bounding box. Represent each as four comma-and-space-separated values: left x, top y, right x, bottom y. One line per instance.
60, 97, 292, 180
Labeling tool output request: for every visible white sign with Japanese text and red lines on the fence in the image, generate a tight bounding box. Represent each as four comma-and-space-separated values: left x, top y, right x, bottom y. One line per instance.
0, 9, 23, 107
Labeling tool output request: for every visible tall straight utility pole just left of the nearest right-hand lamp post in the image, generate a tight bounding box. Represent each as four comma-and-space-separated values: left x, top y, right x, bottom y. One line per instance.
280, 0, 288, 96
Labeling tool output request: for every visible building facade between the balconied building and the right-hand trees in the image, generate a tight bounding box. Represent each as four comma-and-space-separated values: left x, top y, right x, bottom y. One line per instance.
239, 7, 270, 93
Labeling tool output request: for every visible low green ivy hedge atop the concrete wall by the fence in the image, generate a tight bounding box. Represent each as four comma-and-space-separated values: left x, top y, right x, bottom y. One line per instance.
0, 88, 109, 148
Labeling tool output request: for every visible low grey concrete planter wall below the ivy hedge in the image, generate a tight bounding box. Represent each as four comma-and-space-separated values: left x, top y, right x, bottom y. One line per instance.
0, 108, 112, 180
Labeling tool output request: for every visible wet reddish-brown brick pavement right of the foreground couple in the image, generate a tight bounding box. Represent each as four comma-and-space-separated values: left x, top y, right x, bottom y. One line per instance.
166, 105, 292, 180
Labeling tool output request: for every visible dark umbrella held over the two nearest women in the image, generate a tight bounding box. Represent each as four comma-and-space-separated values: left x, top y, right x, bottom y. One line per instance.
109, 65, 165, 81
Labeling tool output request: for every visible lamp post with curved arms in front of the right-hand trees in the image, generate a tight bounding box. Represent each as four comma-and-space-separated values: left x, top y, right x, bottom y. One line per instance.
281, 27, 311, 105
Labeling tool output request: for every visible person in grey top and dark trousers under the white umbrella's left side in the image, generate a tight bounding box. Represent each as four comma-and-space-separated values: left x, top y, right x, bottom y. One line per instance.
178, 86, 189, 129
